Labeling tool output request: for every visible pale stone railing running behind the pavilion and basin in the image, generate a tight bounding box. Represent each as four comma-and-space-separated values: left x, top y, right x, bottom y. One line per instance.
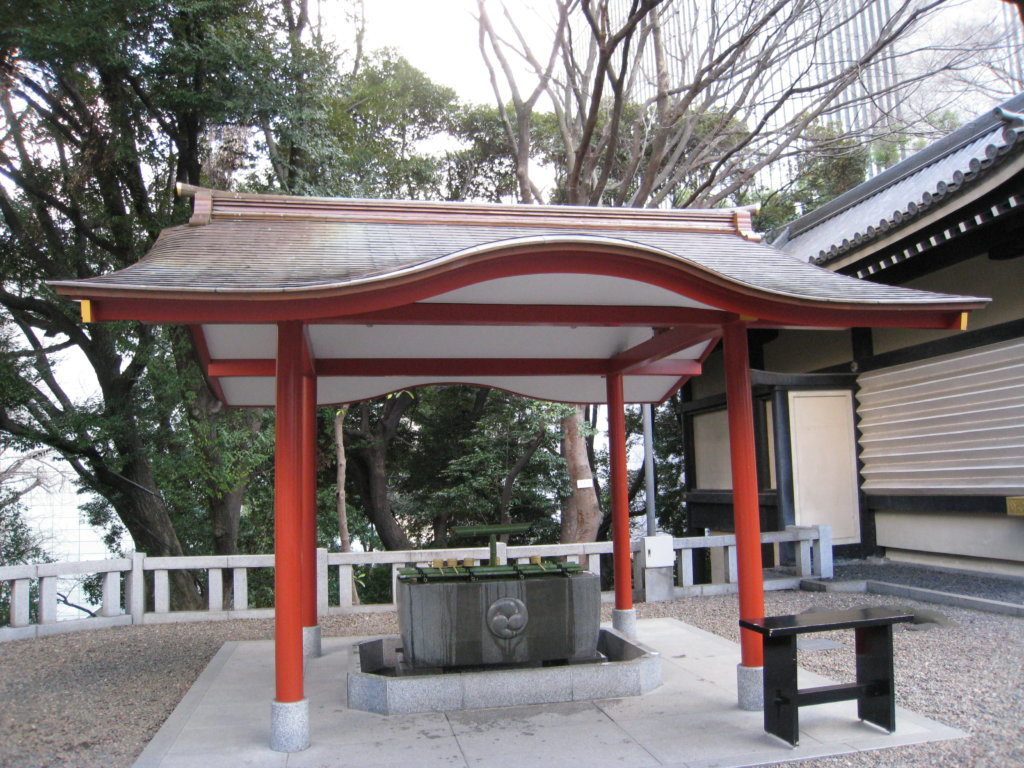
0, 526, 831, 642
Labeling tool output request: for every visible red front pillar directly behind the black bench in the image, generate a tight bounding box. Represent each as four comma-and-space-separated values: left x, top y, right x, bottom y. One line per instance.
723, 323, 765, 667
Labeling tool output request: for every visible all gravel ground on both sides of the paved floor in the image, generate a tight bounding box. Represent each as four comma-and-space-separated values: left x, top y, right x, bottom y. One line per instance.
0, 592, 1024, 768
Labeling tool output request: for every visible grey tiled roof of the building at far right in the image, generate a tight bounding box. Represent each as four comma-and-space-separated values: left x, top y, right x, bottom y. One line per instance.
774, 93, 1024, 264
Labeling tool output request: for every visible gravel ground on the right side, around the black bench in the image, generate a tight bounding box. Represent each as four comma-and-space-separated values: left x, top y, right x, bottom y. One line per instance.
637, 591, 1024, 768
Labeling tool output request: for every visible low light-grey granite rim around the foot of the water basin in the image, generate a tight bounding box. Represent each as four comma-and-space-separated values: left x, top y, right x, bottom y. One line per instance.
348, 629, 662, 715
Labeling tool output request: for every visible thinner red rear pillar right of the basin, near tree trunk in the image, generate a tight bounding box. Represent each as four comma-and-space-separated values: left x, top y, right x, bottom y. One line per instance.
607, 374, 633, 610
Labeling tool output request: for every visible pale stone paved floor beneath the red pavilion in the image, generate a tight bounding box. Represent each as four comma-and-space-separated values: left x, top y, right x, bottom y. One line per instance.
134, 618, 966, 768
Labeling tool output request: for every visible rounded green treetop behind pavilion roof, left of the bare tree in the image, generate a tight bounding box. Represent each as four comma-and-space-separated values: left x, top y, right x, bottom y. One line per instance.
243, 43, 475, 200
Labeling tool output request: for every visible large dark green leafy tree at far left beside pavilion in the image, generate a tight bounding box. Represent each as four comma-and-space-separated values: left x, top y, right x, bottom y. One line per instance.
0, 0, 348, 573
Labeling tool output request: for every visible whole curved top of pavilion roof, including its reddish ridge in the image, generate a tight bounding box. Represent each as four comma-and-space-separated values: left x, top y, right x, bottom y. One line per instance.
53, 189, 973, 305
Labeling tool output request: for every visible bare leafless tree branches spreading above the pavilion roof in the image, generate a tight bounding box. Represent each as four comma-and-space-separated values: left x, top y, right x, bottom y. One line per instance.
478, 0, 983, 207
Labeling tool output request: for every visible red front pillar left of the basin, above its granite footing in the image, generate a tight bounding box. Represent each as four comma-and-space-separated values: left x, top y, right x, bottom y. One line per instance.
273, 322, 304, 703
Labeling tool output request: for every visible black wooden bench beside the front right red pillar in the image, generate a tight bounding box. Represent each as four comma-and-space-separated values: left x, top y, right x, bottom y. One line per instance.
739, 607, 913, 746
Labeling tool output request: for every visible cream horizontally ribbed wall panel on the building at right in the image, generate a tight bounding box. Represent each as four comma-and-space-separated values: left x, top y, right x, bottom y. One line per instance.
857, 339, 1024, 496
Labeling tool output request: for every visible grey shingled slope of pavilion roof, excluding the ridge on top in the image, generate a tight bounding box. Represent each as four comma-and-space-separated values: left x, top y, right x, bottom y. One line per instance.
54, 207, 969, 304
